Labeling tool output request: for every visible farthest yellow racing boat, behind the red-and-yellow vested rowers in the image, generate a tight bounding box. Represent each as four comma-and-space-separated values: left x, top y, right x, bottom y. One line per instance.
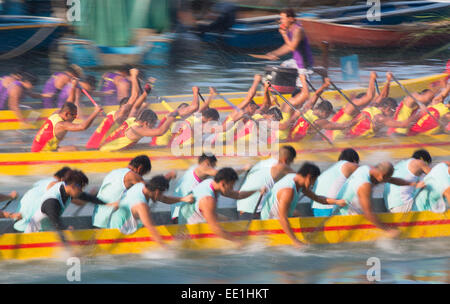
0, 74, 447, 131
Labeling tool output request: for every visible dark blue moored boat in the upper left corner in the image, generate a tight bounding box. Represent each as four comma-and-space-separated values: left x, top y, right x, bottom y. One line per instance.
0, 15, 67, 60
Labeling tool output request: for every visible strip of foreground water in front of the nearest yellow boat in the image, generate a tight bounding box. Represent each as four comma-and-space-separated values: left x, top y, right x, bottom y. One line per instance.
0, 238, 450, 284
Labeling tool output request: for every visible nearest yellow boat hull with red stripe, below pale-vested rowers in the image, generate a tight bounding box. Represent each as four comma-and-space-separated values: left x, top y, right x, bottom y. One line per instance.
0, 211, 450, 260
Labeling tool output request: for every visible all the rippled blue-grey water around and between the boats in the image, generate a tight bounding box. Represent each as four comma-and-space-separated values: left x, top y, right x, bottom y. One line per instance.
0, 27, 450, 283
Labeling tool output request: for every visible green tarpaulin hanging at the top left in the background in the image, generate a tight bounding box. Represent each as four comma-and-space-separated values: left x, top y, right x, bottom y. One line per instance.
73, 0, 170, 46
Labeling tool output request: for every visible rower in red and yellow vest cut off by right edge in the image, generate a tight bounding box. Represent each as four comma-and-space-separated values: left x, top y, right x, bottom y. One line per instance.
408, 82, 450, 135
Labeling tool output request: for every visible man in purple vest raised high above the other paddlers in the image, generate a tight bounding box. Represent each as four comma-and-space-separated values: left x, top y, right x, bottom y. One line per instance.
254, 8, 314, 74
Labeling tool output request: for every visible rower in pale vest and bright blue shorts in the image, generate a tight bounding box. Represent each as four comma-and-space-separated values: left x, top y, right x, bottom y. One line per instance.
311, 148, 359, 216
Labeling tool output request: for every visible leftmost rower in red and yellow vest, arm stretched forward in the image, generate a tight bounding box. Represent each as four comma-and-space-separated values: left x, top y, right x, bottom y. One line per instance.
31, 102, 102, 152
